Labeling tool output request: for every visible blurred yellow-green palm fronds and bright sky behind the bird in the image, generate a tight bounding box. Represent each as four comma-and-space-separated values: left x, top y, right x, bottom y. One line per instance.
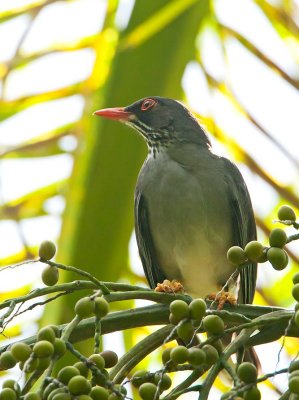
0, 0, 299, 398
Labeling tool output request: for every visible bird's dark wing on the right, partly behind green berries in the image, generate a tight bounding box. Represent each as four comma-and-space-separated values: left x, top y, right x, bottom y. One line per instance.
223, 158, 257, 304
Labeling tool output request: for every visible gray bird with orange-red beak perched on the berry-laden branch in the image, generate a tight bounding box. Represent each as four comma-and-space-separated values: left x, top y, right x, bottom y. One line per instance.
94, 96, 257, 304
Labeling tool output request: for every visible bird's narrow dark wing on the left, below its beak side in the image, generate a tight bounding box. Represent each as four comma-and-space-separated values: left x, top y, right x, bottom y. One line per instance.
135, 188, 166, 289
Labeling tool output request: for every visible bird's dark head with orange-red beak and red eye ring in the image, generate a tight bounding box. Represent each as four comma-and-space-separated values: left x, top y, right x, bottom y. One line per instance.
94, 96, 210, 150
